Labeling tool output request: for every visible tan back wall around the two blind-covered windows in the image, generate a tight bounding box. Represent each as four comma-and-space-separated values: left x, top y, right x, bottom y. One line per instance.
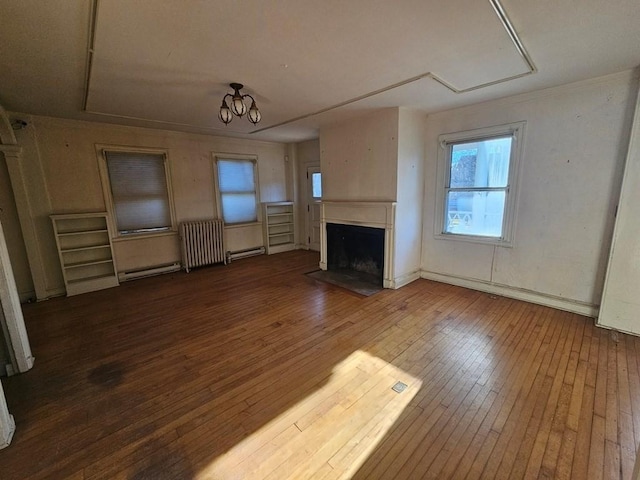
0, 115, 291, 296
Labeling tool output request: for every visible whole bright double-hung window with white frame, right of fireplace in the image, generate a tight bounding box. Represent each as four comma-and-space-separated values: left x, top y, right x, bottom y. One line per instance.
436, 123, 524, 244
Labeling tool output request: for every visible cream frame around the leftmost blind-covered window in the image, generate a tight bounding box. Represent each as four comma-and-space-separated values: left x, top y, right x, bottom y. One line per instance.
96, 144, 178, 241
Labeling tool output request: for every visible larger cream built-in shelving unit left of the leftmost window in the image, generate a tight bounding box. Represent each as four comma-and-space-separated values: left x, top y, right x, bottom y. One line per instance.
51, 213, 119, 296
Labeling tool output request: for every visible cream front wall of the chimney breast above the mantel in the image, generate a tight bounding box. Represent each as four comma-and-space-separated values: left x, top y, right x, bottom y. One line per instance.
320, 108, 398, 201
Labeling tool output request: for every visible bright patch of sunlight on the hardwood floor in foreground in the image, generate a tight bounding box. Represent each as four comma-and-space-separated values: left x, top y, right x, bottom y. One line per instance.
195, 350, 422, 480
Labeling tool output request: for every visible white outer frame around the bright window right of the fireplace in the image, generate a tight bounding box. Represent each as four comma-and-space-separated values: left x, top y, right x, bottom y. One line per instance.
434, 122, 526, 247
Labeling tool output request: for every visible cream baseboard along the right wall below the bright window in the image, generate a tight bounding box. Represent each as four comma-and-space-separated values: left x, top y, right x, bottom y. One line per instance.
421, 270, 598, 318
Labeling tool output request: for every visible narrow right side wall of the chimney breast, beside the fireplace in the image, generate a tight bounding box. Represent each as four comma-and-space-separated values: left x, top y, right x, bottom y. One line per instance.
394, 108, 427, 283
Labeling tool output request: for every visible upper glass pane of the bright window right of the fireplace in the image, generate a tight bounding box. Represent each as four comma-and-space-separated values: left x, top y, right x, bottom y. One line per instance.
449, 136, 512, 188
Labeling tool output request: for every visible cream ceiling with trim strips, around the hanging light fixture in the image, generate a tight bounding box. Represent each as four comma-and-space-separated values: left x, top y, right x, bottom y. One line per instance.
0, 0, 640, 142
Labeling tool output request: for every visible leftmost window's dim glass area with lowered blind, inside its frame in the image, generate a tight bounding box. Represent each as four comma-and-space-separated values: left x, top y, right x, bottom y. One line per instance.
104, 150, 173, 235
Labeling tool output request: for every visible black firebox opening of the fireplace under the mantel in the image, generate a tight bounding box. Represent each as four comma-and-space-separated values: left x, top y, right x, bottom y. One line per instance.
327, 223, 384, 285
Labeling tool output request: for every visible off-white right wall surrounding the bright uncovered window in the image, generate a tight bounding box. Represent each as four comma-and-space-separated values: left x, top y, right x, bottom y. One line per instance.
422, 72, 637, 315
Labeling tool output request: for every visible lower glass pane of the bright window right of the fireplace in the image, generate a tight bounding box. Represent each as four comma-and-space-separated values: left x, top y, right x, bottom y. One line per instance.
445, 191, 505, 237
